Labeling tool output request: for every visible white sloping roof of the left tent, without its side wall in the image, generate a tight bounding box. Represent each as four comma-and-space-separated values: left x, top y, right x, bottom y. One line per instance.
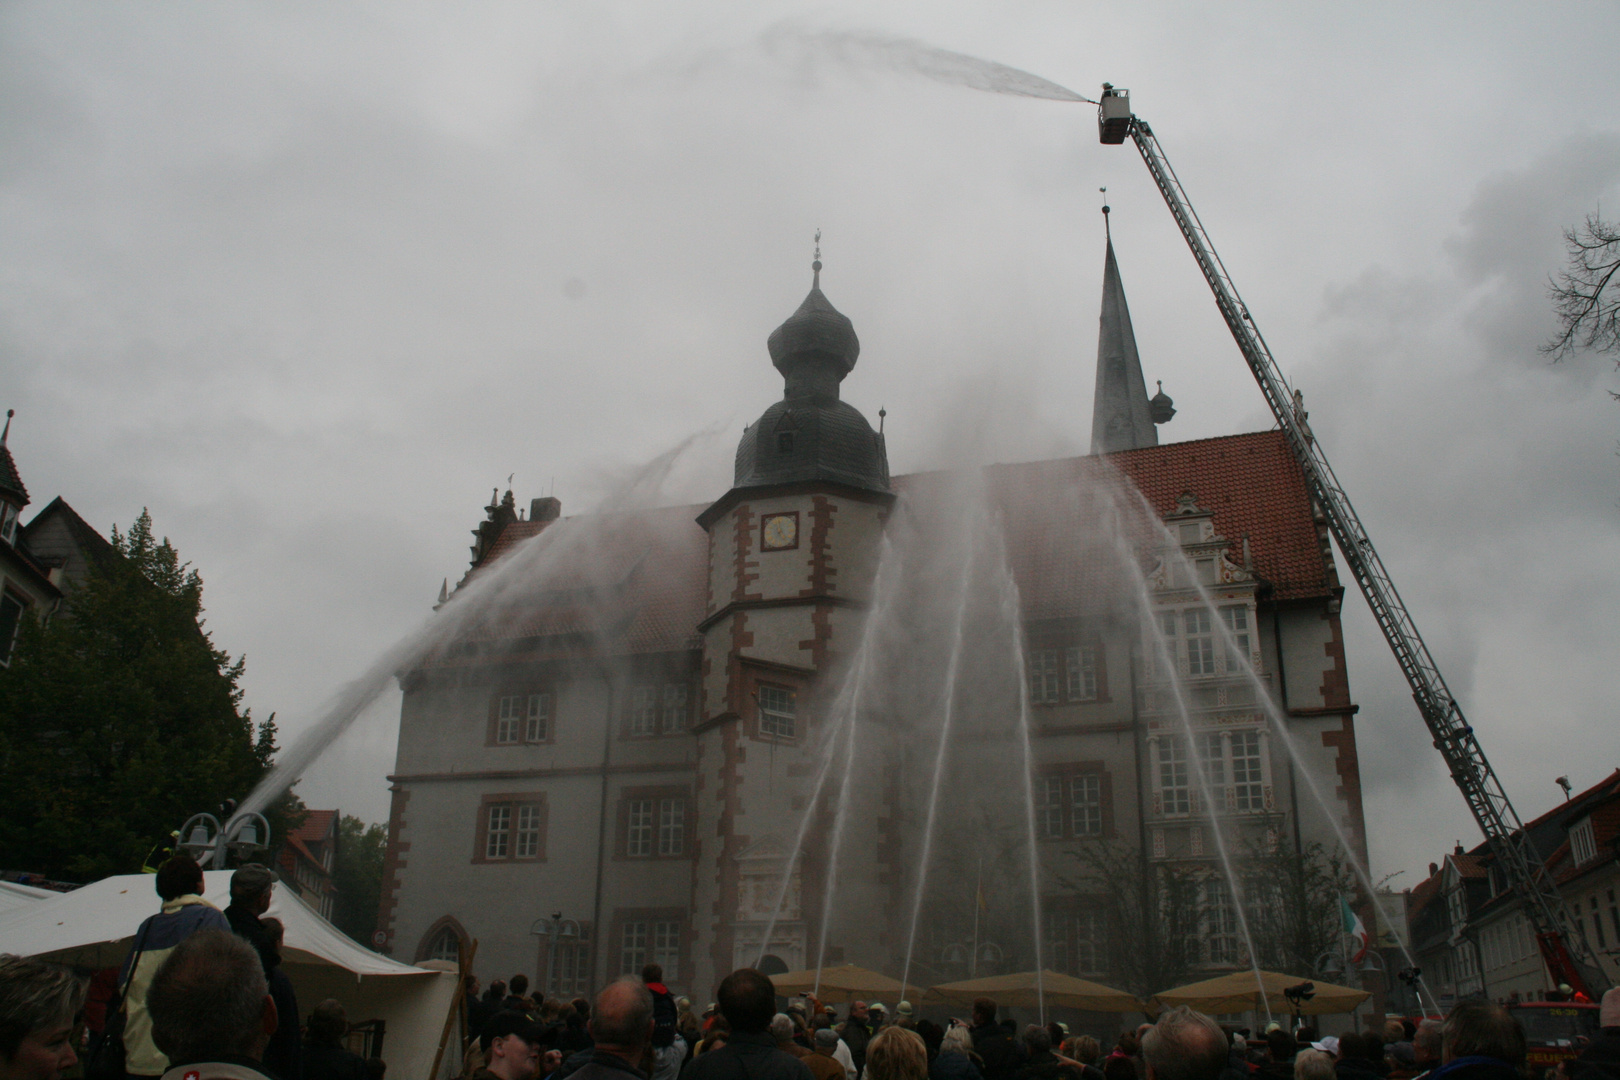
0, 870, 428, 976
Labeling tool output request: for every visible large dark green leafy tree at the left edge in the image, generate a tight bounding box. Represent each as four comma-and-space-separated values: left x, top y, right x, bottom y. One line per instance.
0, 510, 273, 881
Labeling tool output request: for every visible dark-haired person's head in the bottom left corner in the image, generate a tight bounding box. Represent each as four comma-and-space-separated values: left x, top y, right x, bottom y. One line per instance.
0, 955, 84, 1080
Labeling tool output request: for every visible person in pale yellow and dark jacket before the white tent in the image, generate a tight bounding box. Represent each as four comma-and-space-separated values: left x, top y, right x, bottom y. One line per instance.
118, 855, 230, 1077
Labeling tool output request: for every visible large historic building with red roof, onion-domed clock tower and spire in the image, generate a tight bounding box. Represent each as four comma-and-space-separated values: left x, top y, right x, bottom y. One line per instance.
377, 241, 1366, 999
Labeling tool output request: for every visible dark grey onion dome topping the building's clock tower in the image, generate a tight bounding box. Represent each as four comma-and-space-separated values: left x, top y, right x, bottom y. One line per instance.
735, 251, 889, 492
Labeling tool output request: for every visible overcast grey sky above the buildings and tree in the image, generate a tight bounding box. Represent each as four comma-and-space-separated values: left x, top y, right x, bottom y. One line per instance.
0, 0, 1620, 886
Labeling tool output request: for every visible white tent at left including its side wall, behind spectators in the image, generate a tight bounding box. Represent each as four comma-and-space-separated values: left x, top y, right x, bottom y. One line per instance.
0, 870, 458, 1077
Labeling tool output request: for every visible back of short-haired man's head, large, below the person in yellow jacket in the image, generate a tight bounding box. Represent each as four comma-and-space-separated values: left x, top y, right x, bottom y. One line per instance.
146, 929, 278, 1080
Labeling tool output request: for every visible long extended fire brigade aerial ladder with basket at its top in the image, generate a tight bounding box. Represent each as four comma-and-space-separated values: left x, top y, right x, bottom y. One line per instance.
1097, 83, 1605, 999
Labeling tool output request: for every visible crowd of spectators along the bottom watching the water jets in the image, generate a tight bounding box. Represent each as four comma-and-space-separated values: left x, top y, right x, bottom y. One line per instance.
0, 857, 1620, 1080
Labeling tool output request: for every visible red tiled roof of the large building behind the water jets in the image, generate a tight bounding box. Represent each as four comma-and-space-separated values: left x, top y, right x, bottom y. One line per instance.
431, 431, 1337, 665
